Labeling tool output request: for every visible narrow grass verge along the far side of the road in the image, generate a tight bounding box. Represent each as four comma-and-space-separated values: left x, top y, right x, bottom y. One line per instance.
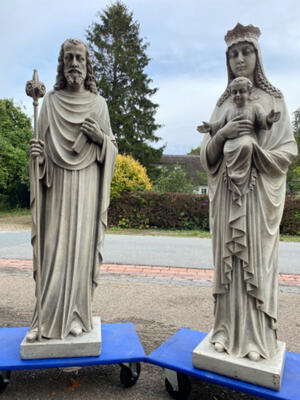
0, 209, 300, 242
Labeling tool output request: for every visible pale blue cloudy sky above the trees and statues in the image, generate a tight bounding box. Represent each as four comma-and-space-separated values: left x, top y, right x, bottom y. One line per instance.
0, 0, 300, 154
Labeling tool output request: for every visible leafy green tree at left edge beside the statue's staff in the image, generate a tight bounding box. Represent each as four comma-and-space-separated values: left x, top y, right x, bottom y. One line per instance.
0, 99, 33, 207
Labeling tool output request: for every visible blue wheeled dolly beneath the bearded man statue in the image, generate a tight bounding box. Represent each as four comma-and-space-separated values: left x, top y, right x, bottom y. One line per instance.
0, 323, 146, 393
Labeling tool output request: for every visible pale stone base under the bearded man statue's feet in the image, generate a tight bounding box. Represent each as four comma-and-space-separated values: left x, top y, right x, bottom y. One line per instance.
20, 317, 101, 360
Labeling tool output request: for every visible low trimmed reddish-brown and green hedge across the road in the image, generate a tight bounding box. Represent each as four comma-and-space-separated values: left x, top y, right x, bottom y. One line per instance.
108, 192, 300, 235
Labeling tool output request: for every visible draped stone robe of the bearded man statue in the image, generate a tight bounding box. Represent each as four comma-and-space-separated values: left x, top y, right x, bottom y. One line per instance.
31, 90, 117, 338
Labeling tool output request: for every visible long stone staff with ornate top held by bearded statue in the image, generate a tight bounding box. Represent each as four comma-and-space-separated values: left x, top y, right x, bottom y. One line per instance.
25, 69, 46, 342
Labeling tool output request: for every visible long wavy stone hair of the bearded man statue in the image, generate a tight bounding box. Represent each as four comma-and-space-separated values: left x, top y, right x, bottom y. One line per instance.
54, 39, 98, 94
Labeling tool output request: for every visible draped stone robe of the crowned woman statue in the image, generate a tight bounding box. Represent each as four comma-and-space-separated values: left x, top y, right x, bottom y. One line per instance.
200, 88, 297, 359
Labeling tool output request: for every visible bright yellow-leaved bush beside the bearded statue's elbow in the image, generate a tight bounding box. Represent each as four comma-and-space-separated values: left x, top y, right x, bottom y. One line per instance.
111, 154, 152, 199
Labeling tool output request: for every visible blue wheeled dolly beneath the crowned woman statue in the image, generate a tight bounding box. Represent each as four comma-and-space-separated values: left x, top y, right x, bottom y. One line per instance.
147, 328, 300, 400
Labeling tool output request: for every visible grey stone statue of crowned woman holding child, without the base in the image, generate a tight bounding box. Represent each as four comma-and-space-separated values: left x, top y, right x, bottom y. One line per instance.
199, 24, 297, 361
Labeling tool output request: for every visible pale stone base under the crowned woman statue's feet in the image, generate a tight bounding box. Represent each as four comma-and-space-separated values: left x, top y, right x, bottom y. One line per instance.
193, 331, 286, 390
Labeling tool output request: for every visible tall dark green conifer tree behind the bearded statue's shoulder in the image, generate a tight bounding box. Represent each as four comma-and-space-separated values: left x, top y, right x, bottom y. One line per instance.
87, 1, 164, 176
